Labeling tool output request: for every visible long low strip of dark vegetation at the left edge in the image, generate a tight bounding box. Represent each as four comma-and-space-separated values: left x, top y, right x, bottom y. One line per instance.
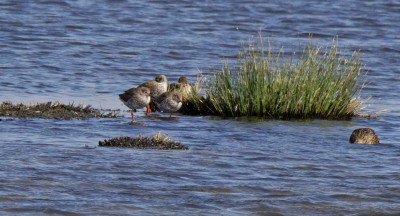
0, 102, 120, 119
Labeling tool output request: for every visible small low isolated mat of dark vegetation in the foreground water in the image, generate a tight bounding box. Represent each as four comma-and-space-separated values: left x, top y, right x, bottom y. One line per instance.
99, 132, 189, 150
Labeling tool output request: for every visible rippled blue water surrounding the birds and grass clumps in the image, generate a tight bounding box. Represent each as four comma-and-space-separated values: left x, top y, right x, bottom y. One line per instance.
0, 0, 400, 215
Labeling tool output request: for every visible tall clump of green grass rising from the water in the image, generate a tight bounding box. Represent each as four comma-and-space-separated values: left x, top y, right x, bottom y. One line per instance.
187, 36, 368, 119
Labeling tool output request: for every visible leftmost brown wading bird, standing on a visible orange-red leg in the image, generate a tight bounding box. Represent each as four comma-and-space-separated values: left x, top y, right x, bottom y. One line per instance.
119, 87, 151, 121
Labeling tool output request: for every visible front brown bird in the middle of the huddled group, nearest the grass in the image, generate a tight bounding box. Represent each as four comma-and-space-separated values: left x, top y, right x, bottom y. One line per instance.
156, 91, 182, 117
